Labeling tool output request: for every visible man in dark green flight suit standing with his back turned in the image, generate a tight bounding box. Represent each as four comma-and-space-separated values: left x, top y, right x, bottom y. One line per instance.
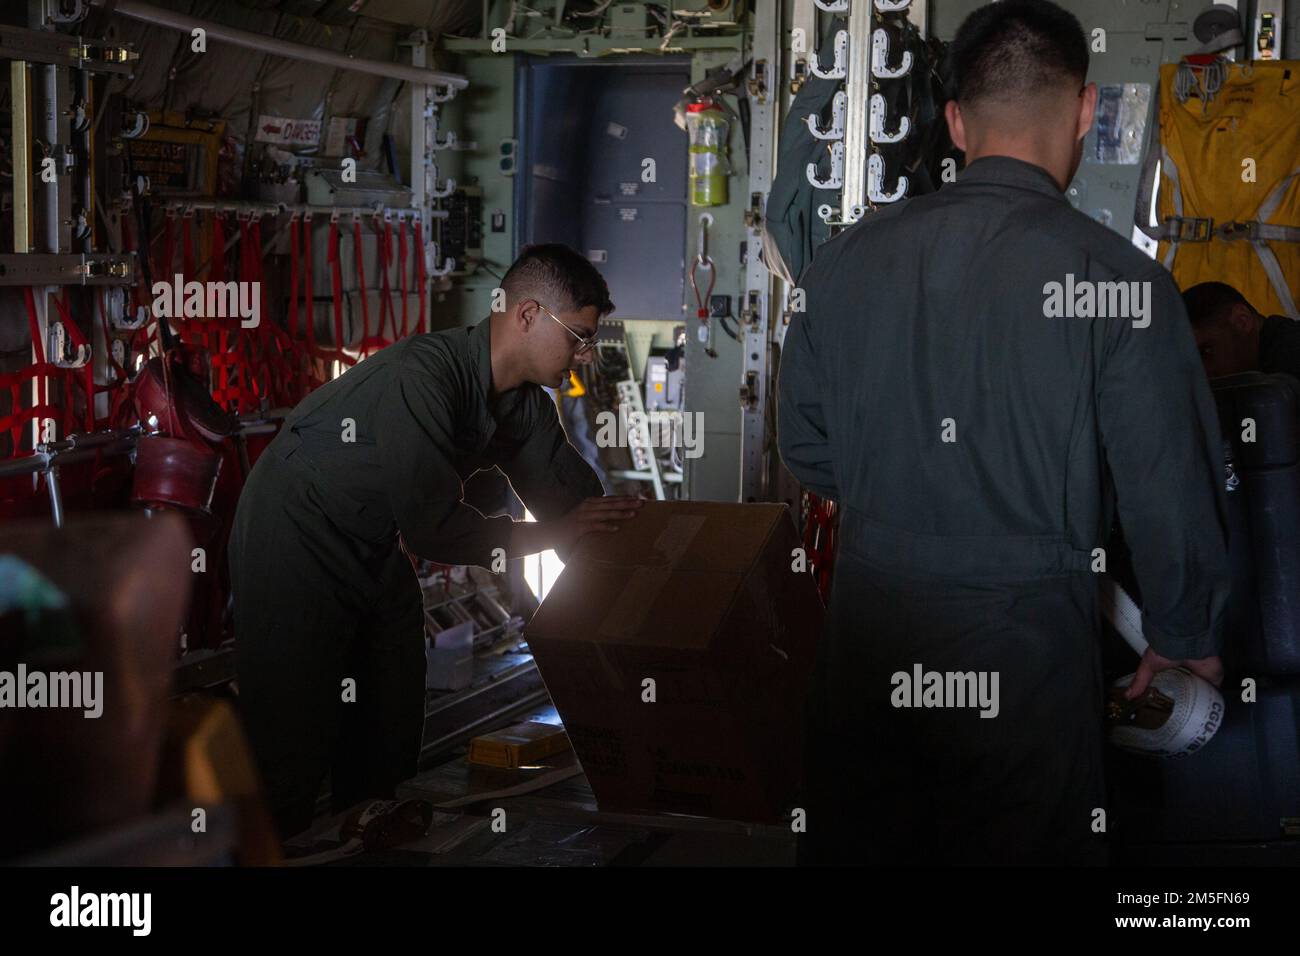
779, 0, 1229, 864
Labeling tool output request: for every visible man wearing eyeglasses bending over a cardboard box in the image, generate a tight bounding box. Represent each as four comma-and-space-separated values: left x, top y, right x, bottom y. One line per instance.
230, 245, 640, 836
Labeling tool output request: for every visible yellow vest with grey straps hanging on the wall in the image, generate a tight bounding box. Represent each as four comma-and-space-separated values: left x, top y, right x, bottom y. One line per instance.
1159, 60, 1300, 319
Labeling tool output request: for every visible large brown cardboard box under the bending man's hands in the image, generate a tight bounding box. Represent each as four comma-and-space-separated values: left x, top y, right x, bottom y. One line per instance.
525, 502, 823, 822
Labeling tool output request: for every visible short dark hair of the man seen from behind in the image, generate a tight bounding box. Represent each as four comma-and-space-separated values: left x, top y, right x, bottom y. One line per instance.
948, 0, 1088, 105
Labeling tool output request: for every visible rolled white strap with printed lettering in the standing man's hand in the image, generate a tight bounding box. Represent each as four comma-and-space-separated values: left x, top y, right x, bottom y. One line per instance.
1106, 667, 1223, 757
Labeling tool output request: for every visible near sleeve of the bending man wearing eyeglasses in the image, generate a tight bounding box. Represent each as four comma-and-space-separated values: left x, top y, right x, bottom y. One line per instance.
377, 364, 514, 567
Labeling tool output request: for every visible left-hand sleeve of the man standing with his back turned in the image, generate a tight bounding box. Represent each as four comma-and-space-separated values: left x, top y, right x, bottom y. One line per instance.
776, 267, 840, 501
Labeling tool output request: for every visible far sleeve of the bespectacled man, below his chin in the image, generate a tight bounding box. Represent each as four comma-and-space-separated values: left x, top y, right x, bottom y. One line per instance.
501, 389, 605, 520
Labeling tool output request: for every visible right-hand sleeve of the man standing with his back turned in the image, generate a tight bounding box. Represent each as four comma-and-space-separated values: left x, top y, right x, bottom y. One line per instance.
1097, 268, 1230, 661
